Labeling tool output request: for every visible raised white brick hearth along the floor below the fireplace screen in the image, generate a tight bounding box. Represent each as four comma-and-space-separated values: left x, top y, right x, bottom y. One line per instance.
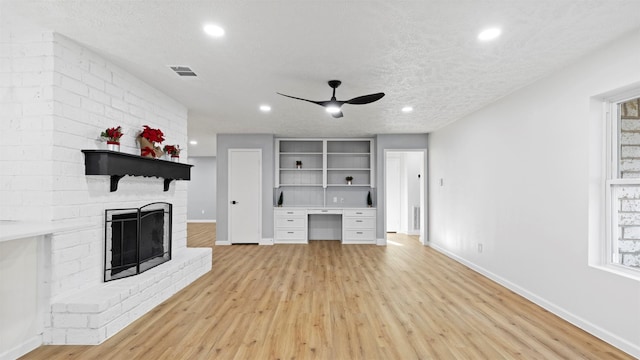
44, 248, 211, 345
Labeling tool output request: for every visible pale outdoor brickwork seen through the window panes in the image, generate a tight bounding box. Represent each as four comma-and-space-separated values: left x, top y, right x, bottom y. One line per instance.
615, 99, 640, 268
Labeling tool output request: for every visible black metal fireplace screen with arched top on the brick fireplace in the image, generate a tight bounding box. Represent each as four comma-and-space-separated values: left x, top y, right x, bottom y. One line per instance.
104, 202, 172, 281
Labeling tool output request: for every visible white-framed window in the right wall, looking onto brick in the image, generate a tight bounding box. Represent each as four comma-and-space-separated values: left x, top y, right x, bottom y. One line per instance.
606, 97, 640, 272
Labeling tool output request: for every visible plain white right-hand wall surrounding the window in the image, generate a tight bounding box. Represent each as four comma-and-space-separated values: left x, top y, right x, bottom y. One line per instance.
429, 31, 640, 356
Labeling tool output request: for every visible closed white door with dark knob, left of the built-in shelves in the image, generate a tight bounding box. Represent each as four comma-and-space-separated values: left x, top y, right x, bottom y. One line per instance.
228, 149, 262, 244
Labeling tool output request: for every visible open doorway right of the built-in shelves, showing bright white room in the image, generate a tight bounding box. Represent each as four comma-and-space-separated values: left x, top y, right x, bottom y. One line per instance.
384, 150, 426, 244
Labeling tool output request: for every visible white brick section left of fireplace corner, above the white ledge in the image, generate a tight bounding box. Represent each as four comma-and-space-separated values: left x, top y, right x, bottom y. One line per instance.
0, 29, 54, 220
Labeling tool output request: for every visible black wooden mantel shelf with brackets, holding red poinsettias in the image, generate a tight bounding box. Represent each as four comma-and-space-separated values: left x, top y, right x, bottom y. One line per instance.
82, 150, 193, 192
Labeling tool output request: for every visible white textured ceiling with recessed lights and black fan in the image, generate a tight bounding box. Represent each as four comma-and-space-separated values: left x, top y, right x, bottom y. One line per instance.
0, 0, 640, 156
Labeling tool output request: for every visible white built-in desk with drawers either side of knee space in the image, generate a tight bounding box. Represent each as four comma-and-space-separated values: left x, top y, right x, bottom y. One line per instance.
274, 207, 376, 244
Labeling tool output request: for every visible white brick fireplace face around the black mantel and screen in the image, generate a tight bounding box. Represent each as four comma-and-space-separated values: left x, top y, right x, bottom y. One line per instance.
46, 34, 187, 297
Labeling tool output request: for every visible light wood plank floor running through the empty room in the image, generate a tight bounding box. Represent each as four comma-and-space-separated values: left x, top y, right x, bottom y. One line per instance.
24, 224, 632, 360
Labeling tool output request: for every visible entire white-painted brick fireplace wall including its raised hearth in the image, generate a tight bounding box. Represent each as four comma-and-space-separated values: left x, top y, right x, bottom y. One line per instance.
0, 25, 211, 359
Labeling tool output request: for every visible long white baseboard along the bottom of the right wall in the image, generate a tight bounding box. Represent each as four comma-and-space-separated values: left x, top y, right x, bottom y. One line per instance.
428, 242, 640, 358
